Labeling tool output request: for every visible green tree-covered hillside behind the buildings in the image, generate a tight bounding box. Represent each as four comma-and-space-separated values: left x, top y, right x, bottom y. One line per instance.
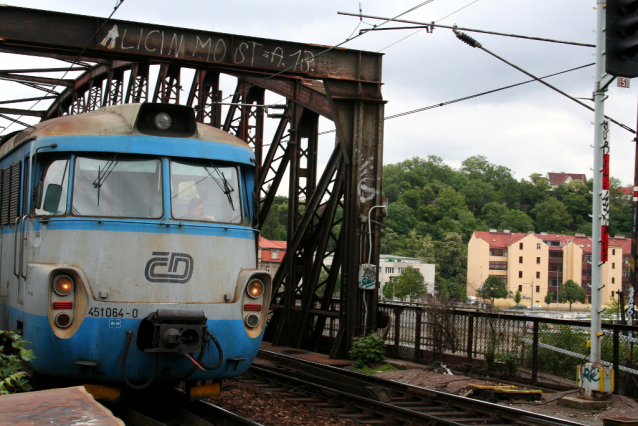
262, 156, 632, 297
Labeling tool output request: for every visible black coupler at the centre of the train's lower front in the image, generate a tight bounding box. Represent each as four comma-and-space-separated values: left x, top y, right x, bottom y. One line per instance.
137, 309, 208, 355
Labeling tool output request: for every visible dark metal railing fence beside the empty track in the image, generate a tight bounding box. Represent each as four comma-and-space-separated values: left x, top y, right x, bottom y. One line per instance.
379, 302, 638, 394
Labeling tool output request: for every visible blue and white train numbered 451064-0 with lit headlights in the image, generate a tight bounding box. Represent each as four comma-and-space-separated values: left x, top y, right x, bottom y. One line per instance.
0, 103, 271, 393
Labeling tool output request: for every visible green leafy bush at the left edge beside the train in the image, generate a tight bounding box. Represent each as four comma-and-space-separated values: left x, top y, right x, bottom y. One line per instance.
0, 331, 35, 395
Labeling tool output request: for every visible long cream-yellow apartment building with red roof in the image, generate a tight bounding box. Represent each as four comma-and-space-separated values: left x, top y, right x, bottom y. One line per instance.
467, 230, 631, 307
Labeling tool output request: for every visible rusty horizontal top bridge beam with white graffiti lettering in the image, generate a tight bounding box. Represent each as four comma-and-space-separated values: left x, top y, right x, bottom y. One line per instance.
0, 6, 381, 83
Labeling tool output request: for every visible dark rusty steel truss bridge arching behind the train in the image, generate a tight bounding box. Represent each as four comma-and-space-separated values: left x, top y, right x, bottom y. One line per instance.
0, 7, 384, 358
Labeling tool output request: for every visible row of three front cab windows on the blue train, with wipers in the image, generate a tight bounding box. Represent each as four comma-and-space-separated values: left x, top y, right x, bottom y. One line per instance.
34, 155, 248, 224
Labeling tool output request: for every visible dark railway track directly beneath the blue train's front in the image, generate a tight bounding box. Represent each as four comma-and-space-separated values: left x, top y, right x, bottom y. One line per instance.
104, 388, 261, 426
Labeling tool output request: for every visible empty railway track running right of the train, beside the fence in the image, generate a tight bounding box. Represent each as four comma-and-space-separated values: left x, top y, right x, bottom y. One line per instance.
244, 350, 582, 426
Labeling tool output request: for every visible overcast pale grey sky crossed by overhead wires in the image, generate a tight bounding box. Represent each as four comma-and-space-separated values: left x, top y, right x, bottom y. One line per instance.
0, 0, 638, 185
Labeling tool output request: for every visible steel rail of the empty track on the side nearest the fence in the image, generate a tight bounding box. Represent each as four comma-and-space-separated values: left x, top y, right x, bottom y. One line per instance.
253, 350, 582, 426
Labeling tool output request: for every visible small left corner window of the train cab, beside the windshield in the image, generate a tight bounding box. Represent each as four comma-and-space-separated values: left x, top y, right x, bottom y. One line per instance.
34, 158, 70, 216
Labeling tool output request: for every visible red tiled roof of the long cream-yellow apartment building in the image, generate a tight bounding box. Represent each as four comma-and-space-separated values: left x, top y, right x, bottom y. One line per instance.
474, 231, 631, 255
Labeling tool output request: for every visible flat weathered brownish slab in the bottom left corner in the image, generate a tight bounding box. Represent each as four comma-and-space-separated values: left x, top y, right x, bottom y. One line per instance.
0, 386, 124, 426
